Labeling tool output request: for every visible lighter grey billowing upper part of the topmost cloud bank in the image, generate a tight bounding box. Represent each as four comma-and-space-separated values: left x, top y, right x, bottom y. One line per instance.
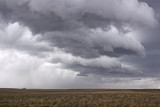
29, 0, 156, 25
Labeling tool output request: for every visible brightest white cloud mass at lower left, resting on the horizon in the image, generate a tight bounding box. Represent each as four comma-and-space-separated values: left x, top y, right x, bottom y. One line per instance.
0, 50, 77, 88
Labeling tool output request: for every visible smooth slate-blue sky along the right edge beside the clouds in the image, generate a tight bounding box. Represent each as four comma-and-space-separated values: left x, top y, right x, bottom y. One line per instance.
117, 0, 160, 78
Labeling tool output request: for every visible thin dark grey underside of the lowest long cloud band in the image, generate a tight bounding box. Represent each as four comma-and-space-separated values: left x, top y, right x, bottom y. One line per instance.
65, 64, 144, 78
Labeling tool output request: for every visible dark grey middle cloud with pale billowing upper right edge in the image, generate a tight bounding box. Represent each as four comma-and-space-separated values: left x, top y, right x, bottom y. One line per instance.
42, 26, 145, 58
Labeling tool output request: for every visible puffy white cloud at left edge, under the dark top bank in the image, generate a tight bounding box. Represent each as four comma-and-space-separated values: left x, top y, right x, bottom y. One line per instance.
0, 22, 52, 54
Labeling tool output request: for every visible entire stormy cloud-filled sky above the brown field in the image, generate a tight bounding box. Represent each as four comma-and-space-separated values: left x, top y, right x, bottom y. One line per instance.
0, 0, 160, 89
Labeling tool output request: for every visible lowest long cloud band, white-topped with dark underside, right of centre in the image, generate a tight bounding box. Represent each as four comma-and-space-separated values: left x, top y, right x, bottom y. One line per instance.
49, 50, 143, 77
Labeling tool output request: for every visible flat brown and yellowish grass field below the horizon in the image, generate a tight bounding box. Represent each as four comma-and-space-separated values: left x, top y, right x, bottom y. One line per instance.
0, 89, 160, 107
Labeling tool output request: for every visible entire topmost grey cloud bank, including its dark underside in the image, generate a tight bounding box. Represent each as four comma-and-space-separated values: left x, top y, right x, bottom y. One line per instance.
0, 0, 157, 33
